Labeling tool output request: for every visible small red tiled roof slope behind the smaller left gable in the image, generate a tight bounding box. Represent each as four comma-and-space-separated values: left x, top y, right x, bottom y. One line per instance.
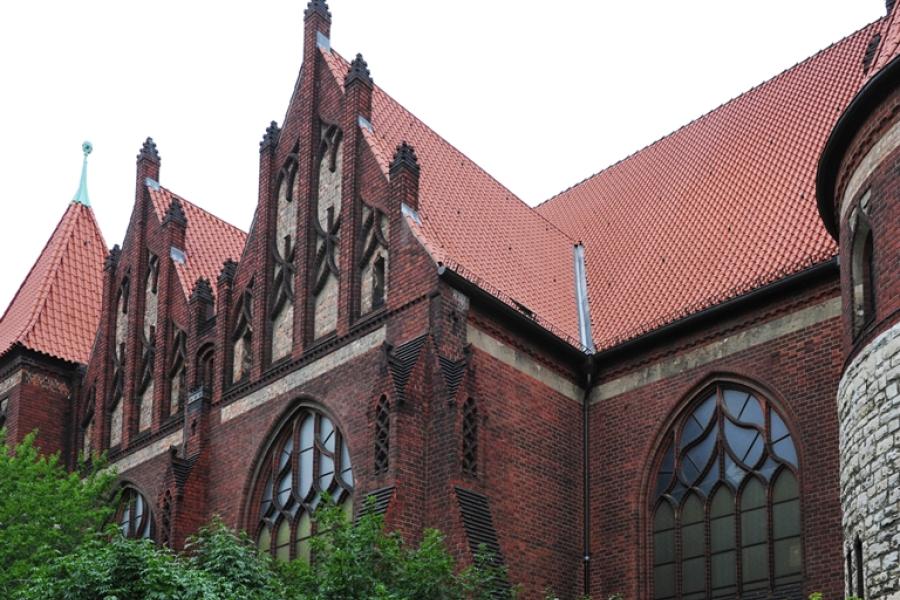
147, 185, 247, 304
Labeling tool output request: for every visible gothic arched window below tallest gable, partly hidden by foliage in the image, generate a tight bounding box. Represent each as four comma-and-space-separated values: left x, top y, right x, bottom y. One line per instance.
255, 406, 353, 561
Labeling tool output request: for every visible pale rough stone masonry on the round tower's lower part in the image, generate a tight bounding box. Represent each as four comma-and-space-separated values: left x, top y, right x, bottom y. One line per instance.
838, 324, 900, 600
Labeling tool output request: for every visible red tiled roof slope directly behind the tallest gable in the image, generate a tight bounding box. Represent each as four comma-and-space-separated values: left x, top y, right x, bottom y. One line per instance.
320, 49, 581, 347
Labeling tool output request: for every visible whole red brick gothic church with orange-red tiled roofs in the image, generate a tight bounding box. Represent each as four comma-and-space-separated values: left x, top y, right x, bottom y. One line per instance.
0, 0, 900, 599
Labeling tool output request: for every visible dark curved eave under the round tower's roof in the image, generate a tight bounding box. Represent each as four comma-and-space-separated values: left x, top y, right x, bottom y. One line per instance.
816, 51, 900, 242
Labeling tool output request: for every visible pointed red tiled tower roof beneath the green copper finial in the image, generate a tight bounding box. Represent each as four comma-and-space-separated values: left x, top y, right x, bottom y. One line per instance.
0, 202, 107, 364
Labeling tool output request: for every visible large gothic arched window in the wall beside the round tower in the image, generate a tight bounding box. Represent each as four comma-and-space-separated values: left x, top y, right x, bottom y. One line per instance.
650, 383, 803, 600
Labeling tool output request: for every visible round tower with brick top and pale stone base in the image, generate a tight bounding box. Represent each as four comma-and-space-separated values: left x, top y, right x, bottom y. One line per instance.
820, 6, 900, 600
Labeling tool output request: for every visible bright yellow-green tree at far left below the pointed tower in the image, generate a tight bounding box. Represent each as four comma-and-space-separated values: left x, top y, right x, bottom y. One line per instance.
0, 430, 115, 598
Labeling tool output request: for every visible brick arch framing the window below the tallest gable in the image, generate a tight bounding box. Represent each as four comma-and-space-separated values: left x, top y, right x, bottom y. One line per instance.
238, 394, 356, 536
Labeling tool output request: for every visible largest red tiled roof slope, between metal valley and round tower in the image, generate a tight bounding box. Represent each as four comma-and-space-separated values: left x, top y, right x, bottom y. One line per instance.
537, 19, 885, 349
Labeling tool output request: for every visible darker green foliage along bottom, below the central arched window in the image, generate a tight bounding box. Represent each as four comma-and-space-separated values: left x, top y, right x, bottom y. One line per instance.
10, 480, 513, 600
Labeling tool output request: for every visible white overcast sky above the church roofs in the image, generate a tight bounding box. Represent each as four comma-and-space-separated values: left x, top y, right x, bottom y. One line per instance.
0, 0, 885, 310
